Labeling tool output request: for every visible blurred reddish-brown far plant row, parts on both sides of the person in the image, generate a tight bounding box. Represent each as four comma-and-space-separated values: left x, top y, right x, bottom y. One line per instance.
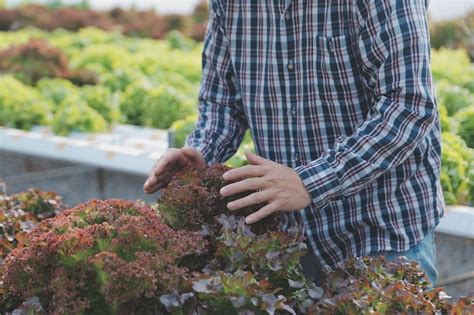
0, 0, 474, 56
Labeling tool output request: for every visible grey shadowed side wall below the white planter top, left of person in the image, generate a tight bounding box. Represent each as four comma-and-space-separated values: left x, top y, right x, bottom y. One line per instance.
0, 151, 157, 206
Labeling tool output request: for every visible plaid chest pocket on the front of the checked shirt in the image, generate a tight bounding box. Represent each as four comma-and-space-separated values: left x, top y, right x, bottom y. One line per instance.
312, 35, 364, 103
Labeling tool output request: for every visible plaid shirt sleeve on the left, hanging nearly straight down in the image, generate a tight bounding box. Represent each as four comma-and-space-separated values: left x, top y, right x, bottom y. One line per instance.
186, 2, 248, 164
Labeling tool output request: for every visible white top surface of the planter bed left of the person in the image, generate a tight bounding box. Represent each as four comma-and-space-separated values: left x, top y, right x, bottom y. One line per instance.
0, 125, 169, 175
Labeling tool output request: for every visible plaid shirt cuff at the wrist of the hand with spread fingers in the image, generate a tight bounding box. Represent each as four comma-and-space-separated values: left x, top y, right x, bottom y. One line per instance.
294, 158, 342, 208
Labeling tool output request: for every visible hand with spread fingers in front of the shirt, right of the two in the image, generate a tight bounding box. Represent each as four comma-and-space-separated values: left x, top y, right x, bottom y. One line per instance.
220, 152, 311, 224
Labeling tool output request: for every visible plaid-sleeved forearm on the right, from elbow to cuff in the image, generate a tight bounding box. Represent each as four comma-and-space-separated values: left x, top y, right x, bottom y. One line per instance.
295, 93, 436, 206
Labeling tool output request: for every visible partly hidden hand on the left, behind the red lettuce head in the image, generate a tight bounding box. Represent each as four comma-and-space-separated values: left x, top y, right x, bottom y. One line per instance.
143, 148, 206, 194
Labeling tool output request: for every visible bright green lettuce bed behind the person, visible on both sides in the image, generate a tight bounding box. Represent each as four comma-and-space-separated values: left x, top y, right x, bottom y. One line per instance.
0, 28, 474, 204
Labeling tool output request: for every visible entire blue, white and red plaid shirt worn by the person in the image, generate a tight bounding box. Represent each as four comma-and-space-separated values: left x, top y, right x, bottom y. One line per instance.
187, 0, 444, 265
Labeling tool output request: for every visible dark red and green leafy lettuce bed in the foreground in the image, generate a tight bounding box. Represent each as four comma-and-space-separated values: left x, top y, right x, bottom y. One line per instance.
0, 165, 474, 315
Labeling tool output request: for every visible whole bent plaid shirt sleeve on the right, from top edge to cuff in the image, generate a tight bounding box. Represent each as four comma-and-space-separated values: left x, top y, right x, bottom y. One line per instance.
295, 0, 437, 211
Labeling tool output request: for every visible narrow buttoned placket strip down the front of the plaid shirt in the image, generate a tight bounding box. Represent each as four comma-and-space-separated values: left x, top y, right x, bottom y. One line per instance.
282, 0, 301, 166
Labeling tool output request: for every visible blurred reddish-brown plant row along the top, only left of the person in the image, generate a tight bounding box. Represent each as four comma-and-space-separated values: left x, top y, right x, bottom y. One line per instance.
0, 1, 208, 41
